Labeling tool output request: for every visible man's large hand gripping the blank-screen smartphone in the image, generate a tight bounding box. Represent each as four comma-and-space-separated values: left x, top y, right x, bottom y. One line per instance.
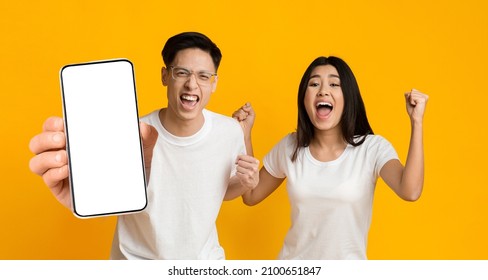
29, 117, 158, 209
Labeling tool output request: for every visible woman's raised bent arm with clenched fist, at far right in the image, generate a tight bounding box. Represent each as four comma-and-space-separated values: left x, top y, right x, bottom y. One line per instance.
380, 90, 429, 201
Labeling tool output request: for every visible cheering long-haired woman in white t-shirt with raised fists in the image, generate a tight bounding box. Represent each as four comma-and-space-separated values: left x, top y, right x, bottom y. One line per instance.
234, 56, 428, 259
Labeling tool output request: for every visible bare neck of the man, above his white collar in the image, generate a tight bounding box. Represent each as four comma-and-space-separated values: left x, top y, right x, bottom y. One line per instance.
159, 108, 205, 137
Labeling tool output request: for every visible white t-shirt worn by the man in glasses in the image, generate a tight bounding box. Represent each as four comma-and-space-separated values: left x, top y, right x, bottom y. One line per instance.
111, 110, 246, 260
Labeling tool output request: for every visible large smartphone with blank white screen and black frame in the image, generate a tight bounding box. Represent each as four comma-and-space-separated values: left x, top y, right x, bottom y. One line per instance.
60, 59, 147, 218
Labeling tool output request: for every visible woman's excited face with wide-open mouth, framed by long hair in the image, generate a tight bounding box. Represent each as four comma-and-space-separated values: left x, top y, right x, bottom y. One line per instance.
305, 65, 344, 132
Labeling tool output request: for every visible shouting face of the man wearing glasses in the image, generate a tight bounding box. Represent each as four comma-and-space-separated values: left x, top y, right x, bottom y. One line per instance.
162, 48, 217, 121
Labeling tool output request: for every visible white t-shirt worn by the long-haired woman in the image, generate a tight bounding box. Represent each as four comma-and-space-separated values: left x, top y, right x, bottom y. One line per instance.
263, 134, 398, 260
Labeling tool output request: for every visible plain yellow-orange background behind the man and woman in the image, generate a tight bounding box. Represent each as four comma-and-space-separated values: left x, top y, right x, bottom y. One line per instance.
0, 0, 488, 259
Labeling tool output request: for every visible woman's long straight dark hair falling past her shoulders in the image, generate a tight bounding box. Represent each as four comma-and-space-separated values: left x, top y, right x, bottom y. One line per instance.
291, 56, 374, 161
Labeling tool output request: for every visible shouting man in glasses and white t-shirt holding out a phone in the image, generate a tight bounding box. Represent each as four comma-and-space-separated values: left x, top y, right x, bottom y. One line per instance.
30, 32, 259, 259
